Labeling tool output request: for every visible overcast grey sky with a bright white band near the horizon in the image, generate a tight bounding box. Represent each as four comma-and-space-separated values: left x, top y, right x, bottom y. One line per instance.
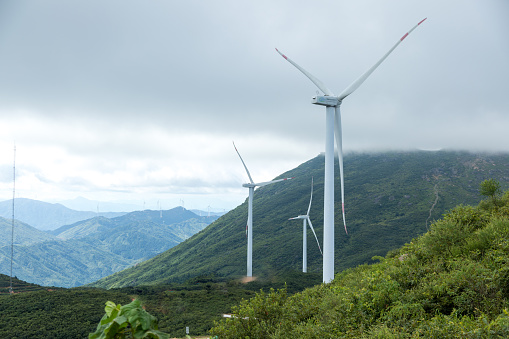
0, 0, 509, 209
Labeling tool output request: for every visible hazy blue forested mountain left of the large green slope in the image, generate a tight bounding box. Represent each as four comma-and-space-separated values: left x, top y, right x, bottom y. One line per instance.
0, 207, 216, 287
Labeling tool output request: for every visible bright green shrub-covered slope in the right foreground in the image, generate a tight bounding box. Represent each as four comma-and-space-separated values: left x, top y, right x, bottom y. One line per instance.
211, 185, 509, 338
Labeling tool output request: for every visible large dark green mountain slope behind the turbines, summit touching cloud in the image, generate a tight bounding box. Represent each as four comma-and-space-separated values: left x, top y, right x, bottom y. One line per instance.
91, 151, 509, 288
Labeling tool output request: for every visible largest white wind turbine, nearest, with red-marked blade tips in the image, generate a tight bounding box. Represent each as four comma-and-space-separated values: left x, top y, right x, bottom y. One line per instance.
276, 18, 426, 283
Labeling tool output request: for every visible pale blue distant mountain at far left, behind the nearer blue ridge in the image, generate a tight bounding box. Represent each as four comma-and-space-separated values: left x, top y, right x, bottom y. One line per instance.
0, 198, 125, 230
